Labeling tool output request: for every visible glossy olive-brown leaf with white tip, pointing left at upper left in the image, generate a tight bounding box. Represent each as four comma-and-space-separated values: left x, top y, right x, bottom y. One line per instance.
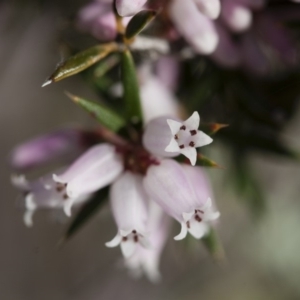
42, 43, 118, 86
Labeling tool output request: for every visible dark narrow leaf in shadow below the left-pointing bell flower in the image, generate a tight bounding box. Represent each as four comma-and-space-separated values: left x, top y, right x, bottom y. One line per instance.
63, 187, 109, 241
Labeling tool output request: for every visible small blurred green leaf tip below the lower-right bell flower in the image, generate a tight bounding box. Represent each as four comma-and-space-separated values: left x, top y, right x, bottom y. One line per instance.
201, 227, 225, 261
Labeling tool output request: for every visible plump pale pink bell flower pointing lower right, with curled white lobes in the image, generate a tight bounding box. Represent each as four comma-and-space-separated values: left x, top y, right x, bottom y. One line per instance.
144, 160, 220, 240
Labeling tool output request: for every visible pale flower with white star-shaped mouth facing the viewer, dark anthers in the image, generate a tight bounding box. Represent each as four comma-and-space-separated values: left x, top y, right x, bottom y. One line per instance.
143, 112, 213, 165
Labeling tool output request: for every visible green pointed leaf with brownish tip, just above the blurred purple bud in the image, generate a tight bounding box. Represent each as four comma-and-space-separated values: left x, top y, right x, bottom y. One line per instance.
66, 92, 126, 132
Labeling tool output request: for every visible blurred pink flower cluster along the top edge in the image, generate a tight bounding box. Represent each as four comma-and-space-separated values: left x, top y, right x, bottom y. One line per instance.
78, 0, 299, 74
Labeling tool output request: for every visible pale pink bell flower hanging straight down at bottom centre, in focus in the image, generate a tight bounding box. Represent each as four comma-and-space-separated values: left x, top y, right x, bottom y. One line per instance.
105, 172, 150, 258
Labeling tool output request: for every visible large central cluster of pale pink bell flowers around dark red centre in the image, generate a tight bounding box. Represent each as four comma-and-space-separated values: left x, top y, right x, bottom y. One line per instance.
13, 101, 219, 281
